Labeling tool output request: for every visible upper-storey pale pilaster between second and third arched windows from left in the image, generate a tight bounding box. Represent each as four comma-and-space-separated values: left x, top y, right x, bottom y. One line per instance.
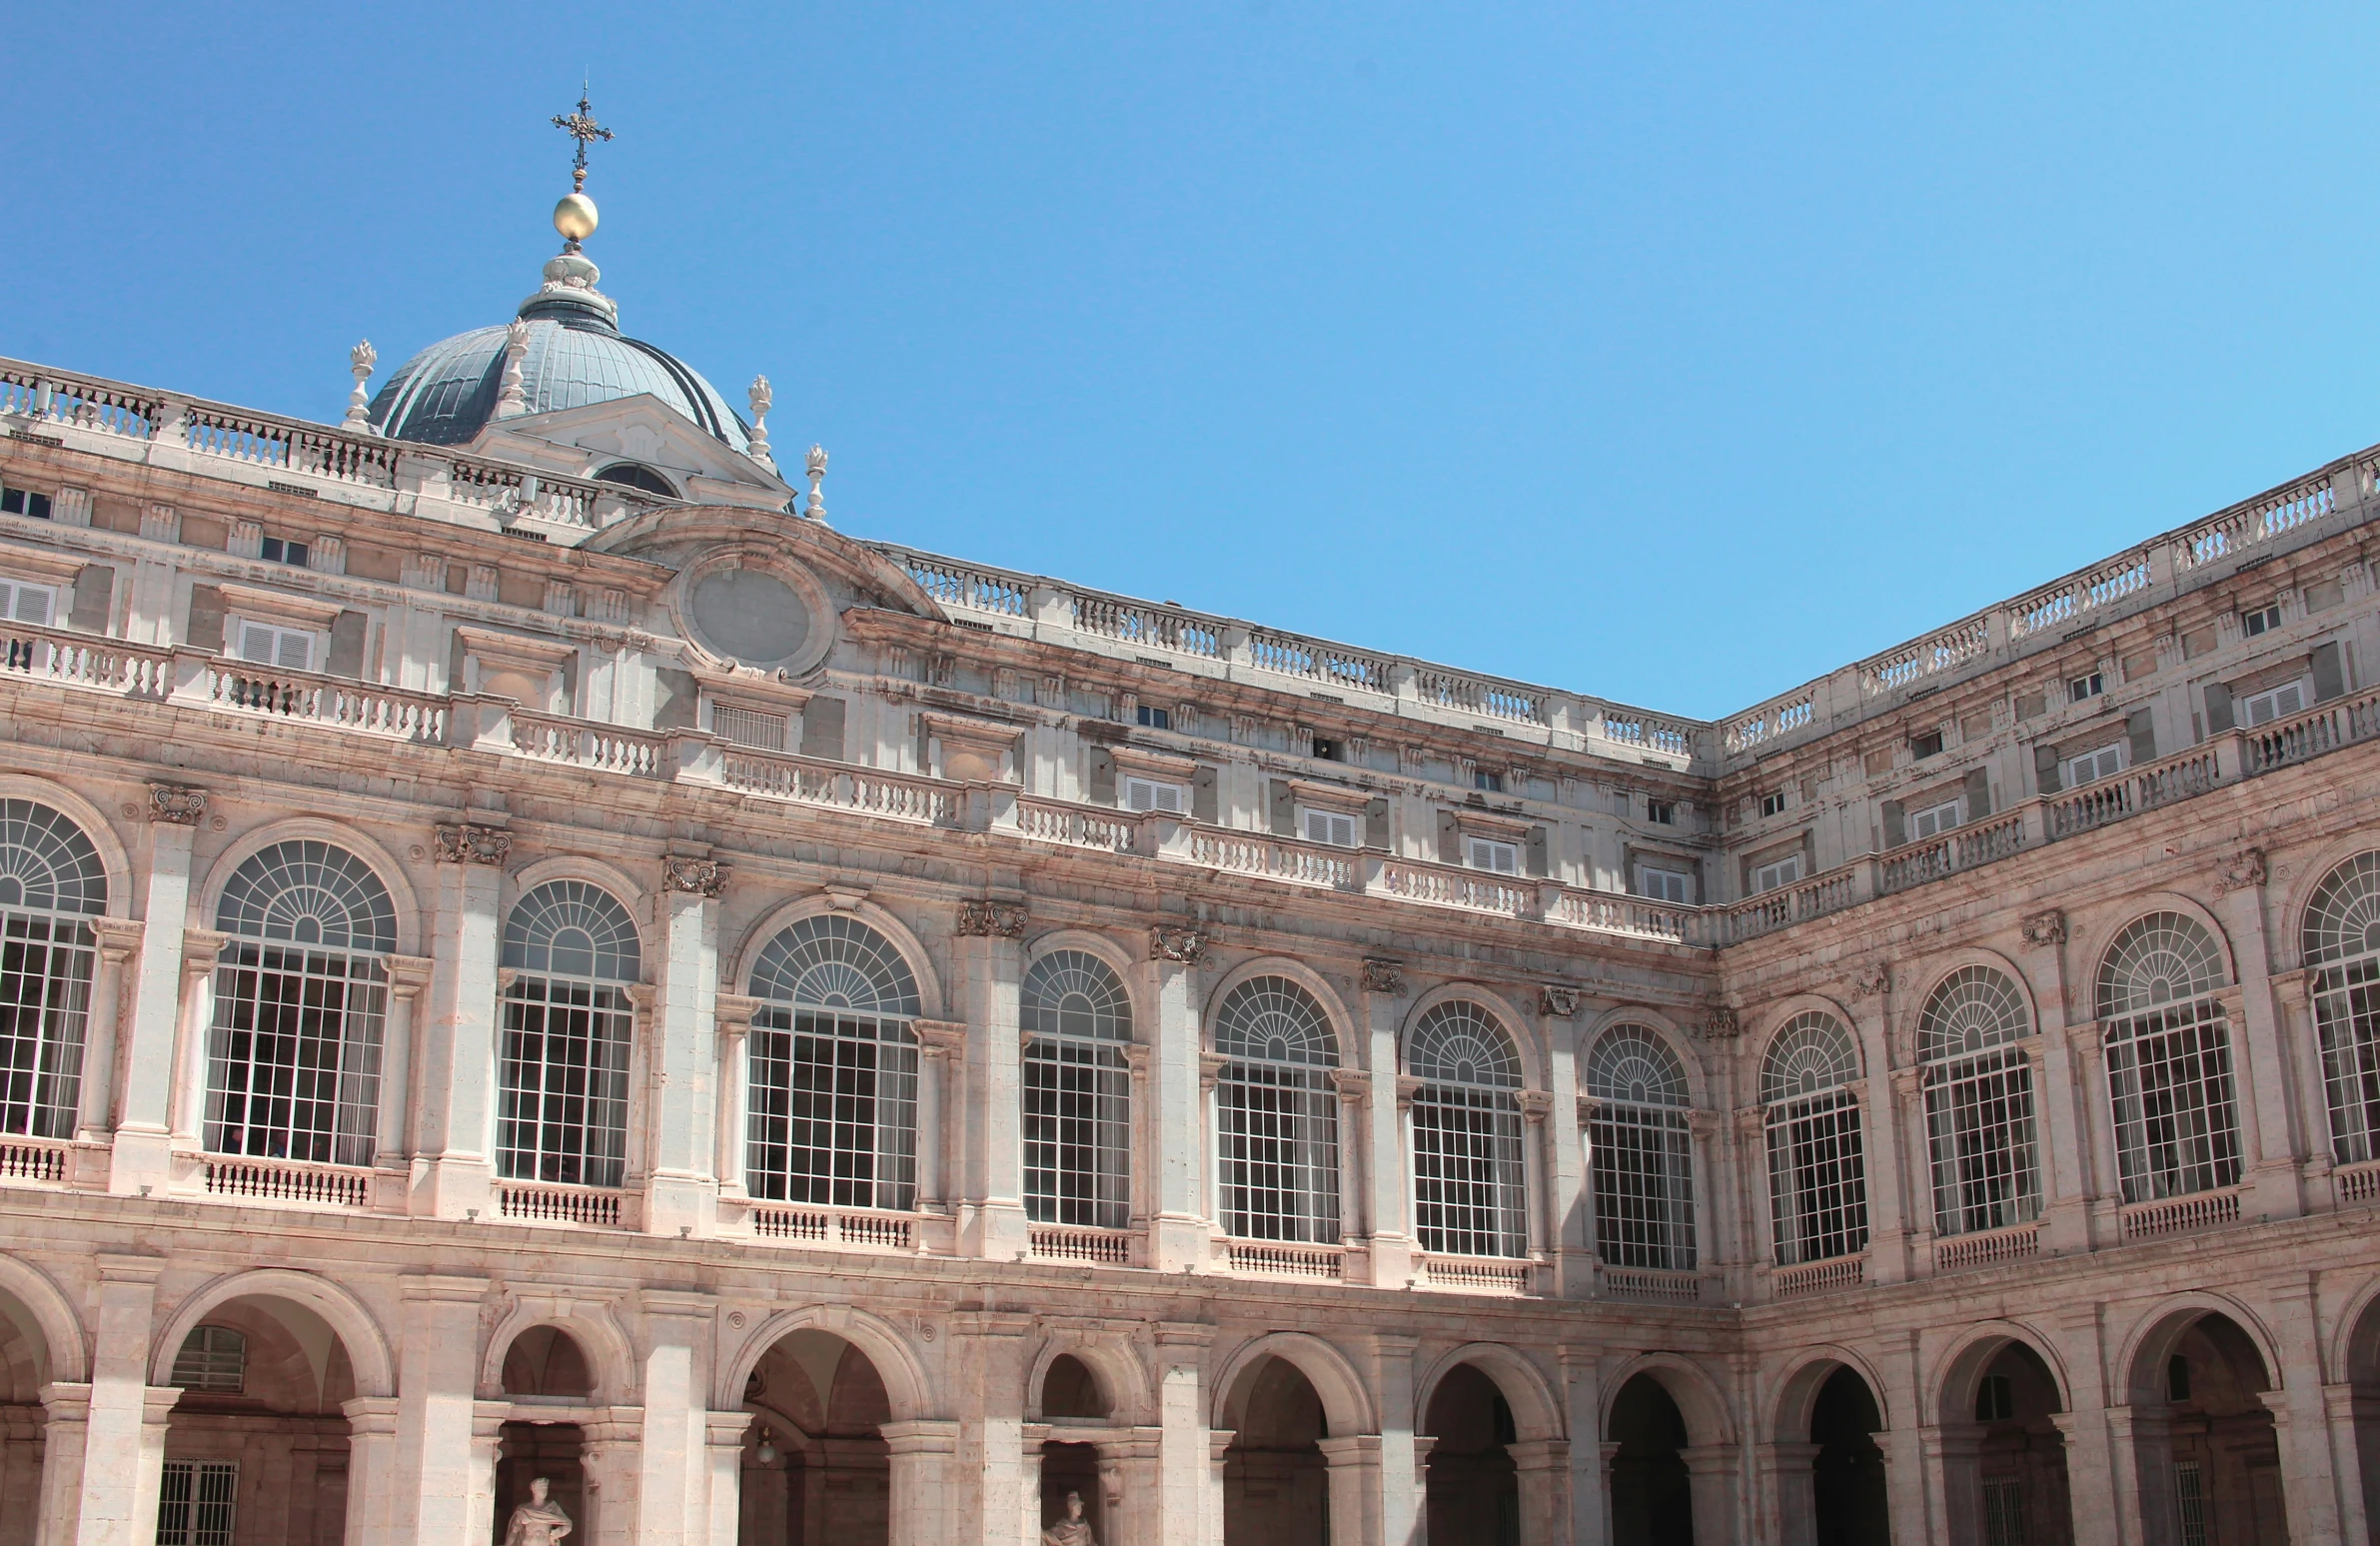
412, 821, 512, 1219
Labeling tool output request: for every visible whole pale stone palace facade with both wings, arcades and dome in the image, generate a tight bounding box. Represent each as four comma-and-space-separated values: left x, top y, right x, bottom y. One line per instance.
0, 208, 2380, 1546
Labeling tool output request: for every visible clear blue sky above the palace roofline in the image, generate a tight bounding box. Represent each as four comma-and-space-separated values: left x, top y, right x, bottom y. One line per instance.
0, 0, 2380, 717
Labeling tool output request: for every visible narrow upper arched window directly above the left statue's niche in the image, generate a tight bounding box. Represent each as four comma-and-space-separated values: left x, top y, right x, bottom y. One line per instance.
495, 881, 640, 1186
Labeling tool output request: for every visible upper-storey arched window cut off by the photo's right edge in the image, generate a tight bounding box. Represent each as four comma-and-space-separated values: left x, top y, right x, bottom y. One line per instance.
2299, 852, 2380, 1165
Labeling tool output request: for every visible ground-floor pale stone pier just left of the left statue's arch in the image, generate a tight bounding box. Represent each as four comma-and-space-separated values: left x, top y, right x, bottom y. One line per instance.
388, 1274, 493, 1544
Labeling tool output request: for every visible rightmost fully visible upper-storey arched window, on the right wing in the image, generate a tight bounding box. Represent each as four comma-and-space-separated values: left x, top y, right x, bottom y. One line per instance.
2099, 912, 2239, 1203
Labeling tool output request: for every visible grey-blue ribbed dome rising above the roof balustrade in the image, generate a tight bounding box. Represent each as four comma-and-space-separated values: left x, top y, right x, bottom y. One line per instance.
372, 255, 749, 451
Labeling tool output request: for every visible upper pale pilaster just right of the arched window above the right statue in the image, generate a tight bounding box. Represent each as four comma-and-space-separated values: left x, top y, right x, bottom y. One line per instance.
1135, 926, 1214, 1267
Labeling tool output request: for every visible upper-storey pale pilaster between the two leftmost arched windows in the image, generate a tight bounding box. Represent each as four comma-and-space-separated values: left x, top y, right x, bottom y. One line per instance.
107, 783, 207, 1195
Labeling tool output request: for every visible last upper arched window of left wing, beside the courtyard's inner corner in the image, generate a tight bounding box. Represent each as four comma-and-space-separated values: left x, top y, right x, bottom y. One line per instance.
1588, 1024, 1695, 1272
